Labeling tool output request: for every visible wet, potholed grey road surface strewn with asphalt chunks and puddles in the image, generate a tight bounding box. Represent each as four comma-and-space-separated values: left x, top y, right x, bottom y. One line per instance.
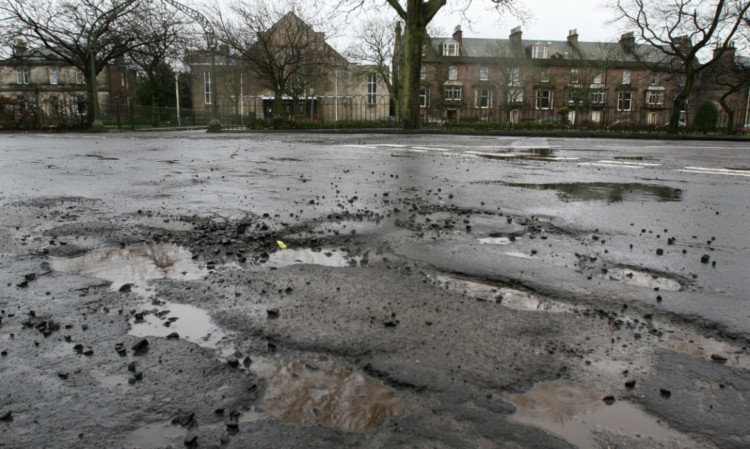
0, 132, 750, 449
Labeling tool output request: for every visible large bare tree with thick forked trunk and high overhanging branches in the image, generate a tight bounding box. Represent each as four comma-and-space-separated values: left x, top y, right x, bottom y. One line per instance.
341, 0, 518, 129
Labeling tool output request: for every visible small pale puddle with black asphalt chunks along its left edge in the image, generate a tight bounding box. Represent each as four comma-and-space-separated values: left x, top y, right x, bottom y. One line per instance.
129, 303, 226, 348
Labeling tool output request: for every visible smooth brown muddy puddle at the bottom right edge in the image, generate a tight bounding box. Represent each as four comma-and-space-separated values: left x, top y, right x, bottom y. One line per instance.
504, 381, 693, 449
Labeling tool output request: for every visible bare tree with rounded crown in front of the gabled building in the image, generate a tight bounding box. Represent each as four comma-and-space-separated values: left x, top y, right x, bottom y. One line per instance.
216, 2, 345, 117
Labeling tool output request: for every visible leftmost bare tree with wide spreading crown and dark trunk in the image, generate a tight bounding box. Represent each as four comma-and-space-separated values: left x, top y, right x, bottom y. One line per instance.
0, 0, 153, 127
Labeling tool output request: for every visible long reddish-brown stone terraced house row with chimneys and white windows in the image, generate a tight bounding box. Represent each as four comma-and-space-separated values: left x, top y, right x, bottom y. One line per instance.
412, 26, 750, 129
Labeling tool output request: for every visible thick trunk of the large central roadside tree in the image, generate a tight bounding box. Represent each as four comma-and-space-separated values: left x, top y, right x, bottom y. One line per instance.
399, 0, 427, 129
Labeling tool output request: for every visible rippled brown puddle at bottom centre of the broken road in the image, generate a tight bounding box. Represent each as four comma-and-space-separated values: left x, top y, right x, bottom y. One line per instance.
252, 356, 404, 434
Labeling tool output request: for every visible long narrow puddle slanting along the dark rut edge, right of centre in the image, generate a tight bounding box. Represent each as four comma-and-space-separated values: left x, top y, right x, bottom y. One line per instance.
436, 276, 570, 312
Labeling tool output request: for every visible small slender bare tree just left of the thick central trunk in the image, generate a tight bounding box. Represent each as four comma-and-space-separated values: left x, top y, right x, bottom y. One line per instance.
347, 17, 401, 119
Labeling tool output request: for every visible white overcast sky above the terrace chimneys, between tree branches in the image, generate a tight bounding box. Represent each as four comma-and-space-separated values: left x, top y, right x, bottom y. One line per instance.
433, 0, 620, 42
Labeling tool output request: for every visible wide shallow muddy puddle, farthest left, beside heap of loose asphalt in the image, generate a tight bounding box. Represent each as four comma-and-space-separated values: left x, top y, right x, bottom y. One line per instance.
49, 244, 206, 290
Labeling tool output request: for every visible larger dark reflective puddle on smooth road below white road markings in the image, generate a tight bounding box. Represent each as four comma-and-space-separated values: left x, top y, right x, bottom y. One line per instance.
504, 182, 682, 203
